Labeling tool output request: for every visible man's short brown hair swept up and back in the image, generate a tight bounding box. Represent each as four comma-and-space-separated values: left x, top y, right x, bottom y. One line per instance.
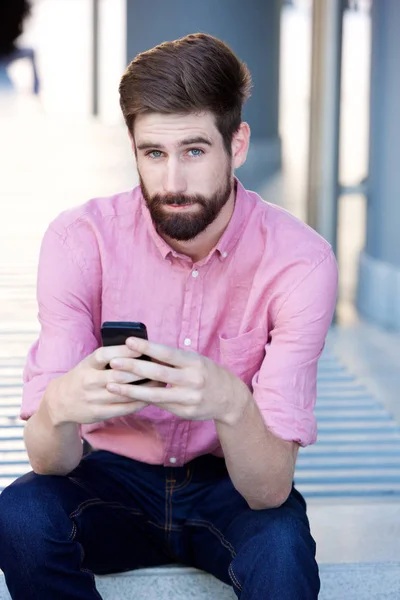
119, 33, 251, 154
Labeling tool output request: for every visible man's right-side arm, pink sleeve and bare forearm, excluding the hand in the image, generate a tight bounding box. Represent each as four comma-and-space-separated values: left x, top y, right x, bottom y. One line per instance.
216, 248, 337, 508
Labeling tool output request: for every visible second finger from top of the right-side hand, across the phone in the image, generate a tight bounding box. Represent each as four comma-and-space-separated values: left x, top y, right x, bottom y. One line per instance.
110, 358, 191, 387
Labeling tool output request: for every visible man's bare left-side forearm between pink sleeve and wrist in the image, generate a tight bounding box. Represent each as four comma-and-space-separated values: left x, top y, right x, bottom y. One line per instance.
24, 384, 83, 475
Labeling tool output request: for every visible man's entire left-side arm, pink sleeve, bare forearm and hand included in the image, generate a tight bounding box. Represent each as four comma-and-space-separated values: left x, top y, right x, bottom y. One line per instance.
21, 229, 155, 475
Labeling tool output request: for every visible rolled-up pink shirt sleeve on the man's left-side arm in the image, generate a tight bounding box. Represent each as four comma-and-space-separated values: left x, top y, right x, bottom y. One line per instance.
20, 227, 99, 420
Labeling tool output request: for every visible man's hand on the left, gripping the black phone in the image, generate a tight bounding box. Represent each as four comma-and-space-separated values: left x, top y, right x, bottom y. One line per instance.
45, 345, 163, 424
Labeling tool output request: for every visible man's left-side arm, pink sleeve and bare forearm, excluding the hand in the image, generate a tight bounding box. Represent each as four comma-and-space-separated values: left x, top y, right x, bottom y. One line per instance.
21, 227, 98, 474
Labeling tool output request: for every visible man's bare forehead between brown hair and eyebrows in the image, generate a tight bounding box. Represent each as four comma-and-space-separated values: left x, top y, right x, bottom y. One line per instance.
133, 112, 221, 145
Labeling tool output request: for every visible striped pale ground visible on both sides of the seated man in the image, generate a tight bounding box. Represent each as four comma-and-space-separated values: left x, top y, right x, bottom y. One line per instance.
0, 322, 400, 498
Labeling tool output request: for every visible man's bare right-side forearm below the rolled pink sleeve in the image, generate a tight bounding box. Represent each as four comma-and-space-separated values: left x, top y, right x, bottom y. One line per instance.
216, 390, 297, 509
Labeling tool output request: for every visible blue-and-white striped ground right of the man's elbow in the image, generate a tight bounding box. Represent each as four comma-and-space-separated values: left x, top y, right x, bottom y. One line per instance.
295, 350, 400, 498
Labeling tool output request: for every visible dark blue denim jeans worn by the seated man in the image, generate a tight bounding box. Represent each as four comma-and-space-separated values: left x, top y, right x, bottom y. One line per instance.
0, 450, 319, 600
